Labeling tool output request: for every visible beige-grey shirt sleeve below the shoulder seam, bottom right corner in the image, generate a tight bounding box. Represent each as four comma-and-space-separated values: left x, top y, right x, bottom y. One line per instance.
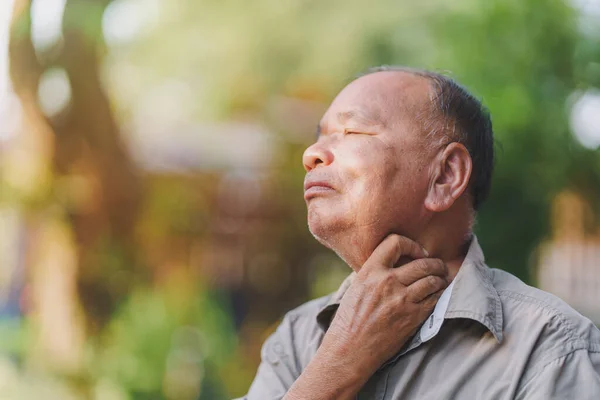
516, 349, 600, 400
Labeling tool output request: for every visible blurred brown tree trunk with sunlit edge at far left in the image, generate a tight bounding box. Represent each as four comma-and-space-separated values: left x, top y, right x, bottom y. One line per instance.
8, 0, 140, 372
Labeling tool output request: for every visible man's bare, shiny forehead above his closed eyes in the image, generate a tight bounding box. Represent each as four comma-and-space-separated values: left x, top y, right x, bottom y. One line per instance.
322, 71, 431, 127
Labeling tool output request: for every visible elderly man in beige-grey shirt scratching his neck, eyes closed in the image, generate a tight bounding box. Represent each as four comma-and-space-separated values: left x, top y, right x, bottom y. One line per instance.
237, 68, 600, 400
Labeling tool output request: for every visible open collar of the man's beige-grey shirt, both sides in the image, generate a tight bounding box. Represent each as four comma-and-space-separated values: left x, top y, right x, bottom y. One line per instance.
317, 235, 503, 342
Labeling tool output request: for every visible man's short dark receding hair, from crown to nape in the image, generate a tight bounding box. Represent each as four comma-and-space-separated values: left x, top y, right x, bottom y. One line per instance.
362, 66, 494, 211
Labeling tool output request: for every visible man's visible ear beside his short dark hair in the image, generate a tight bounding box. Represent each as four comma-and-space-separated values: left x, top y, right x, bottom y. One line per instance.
425, 142, 473, 212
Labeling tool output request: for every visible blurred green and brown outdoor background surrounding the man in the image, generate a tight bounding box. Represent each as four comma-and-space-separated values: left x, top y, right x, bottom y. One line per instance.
0, 0, 600, 400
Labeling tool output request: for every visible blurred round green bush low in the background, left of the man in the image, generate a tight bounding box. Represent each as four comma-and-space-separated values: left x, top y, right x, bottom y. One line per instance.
89, 282, 235, 398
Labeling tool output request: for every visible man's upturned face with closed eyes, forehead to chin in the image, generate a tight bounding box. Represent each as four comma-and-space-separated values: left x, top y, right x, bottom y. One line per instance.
303, 71, 432, 249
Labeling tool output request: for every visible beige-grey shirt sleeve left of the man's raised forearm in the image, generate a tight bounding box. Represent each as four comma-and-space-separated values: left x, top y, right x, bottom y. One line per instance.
233, 316, 301, 400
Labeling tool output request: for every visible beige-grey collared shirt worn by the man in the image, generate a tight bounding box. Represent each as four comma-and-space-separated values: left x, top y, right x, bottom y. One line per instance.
238, 238, 600, 400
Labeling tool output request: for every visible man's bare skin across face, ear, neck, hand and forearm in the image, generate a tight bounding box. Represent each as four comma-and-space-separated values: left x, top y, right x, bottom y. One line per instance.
285, 71, 472, 400
